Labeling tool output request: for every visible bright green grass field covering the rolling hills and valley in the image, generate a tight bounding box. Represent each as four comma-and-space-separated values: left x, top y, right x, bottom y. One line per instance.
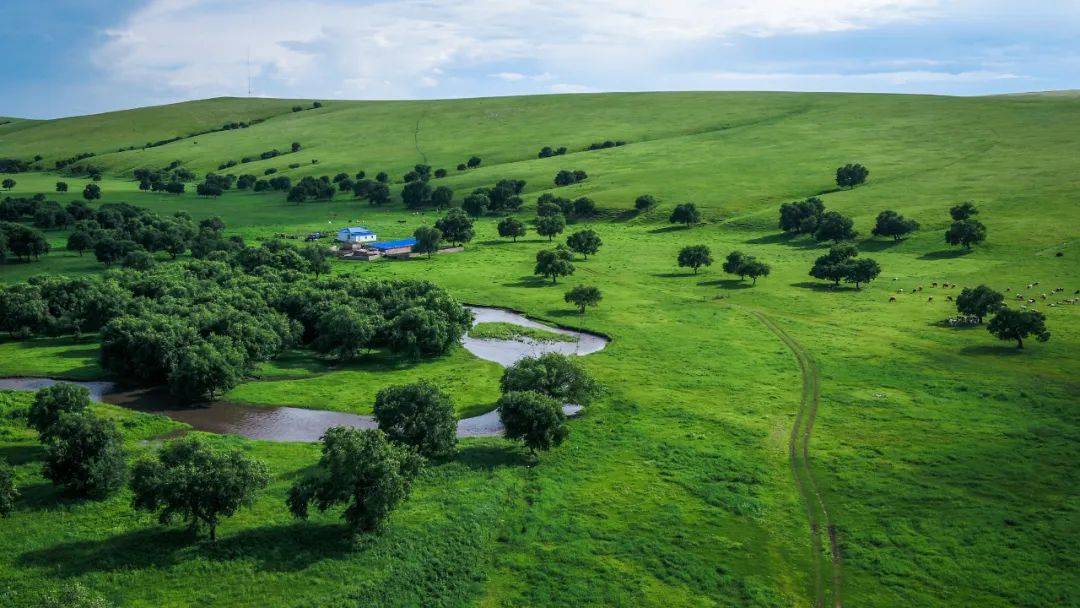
0, 93, 1080, 607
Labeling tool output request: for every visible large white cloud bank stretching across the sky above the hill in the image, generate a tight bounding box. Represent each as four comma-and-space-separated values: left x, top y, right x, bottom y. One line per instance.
94, 0, 937, 97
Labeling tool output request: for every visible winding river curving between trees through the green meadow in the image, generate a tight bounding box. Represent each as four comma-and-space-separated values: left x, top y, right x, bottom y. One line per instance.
0, 307, 608, 442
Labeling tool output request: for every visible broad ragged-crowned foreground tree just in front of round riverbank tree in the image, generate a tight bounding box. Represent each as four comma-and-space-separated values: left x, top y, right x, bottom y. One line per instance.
286, 427, 423, 532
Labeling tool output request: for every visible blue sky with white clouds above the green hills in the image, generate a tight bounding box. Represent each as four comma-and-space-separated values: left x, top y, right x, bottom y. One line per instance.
0, 0, 1080, 118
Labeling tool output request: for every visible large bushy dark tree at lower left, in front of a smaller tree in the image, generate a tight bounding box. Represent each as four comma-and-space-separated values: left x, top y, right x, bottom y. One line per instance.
43, 411, 127, 498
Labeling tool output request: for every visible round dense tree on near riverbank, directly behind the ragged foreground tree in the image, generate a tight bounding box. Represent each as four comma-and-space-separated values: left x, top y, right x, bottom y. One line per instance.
375, 380, 458, 458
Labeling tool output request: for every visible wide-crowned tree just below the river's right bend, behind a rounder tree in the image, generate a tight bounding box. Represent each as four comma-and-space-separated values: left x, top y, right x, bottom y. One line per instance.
499, 353, 599, 405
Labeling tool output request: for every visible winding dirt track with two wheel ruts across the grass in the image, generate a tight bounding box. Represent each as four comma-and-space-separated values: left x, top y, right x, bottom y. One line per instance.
750, 310, 843, 608
